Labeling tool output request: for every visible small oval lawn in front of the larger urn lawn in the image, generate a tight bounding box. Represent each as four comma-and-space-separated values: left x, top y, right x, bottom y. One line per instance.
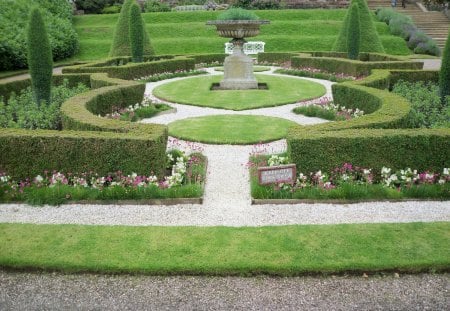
169, 115, 296, 145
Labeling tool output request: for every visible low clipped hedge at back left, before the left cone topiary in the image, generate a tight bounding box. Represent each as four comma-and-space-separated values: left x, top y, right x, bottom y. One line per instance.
62, 56, 195, 80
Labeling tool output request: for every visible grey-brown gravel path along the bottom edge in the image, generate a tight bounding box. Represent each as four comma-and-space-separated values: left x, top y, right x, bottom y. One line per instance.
0, 271, 450, 310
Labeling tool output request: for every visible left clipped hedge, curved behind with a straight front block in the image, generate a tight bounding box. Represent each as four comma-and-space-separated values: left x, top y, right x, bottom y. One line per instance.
0, 74, 167, 178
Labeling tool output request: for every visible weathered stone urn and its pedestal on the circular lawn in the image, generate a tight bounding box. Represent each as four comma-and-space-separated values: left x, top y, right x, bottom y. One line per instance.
206, 20, 269, 90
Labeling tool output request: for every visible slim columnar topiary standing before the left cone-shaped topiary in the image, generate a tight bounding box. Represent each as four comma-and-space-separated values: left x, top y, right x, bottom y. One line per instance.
129, 3, 144, 63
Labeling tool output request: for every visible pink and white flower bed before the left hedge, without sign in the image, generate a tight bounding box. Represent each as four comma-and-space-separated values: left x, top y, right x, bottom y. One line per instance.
0, 150, 206, 205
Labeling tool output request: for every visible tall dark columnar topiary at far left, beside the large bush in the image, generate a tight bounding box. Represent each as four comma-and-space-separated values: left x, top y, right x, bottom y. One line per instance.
27, 7, 53, 105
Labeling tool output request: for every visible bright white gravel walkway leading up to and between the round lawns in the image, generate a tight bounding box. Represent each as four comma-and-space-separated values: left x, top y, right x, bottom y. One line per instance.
0, 70, 450, 227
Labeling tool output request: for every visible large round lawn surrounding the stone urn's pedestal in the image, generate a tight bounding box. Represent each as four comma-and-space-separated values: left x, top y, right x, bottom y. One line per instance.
153, 74, 326, 110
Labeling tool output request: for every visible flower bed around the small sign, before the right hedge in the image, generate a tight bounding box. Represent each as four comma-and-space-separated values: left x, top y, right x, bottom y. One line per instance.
248, 155, 450, 201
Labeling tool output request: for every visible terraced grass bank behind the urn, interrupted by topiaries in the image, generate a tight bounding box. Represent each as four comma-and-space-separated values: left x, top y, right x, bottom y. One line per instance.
73, 9, 411, 60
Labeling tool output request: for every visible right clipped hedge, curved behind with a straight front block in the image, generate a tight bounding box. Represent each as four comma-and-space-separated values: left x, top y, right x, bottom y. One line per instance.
287, 70, 450, 173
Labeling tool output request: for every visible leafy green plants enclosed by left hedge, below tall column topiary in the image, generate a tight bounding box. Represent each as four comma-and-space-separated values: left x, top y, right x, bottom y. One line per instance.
0, 80, 88, 129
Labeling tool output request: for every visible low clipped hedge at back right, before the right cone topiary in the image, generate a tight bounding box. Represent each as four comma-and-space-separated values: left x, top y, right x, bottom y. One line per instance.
291, 56, 423, 77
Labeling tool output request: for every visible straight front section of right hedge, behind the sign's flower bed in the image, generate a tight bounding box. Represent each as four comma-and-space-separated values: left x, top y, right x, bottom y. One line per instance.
288, 128, 450, 173
